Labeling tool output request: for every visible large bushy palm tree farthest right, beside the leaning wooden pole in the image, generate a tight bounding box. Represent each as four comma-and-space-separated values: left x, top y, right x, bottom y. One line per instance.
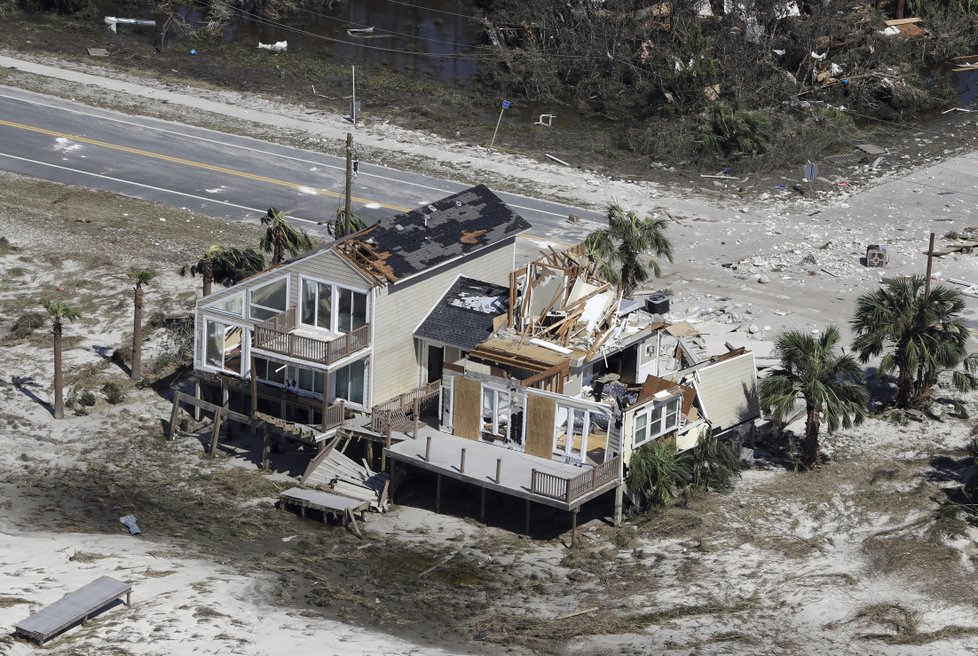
851, 276, 978, 409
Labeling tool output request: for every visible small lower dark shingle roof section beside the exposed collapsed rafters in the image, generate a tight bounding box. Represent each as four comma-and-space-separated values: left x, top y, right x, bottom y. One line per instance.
414, 277, 509, 351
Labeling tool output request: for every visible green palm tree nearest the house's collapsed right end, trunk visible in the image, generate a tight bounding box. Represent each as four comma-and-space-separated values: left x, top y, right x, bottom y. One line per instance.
760, 326, 869, 470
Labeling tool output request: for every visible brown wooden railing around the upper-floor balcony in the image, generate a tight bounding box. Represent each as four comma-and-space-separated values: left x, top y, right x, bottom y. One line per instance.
254, 307, 370, 365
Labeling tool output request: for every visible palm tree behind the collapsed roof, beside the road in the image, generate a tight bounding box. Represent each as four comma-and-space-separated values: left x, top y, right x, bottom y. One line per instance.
584, 203, 672, 296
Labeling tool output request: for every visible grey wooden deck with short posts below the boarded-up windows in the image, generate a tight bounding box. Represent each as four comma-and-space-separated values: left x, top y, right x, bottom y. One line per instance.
386, 425, 621, 510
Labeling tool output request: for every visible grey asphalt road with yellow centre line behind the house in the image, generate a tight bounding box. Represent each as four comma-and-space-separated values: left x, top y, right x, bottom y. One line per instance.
0, 86, 600, 242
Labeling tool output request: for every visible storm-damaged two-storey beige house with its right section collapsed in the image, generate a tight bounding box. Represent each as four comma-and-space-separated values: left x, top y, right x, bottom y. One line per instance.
185, 186, 759, 536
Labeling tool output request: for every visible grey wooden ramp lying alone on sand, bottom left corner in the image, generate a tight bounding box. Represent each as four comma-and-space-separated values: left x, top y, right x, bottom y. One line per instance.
14, 576, 132, 644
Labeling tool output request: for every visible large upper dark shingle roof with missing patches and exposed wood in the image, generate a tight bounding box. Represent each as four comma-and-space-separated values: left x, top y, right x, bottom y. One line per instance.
344, 185, 530, 281
